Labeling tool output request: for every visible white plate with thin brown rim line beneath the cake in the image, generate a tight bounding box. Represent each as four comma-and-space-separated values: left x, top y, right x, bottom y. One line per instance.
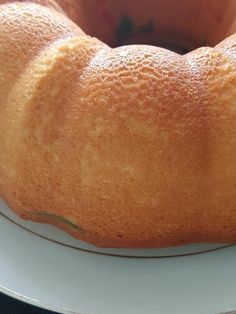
0, 202, 236, 314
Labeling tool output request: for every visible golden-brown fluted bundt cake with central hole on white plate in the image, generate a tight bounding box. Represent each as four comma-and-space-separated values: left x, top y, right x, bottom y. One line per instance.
0, 0, 236, 248
